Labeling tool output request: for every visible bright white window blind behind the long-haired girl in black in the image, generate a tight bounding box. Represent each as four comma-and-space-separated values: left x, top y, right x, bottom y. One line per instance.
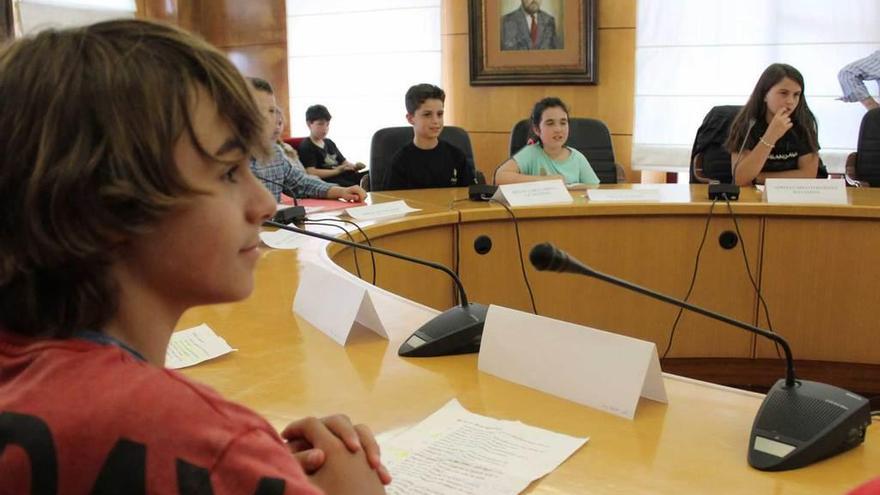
633, 0, 880, 171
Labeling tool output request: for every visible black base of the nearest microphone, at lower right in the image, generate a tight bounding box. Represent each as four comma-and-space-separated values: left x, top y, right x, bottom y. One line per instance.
748, 380, 871, 471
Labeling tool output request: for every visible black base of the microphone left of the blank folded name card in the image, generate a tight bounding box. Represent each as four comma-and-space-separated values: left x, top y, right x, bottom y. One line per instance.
397, 303, 489, 357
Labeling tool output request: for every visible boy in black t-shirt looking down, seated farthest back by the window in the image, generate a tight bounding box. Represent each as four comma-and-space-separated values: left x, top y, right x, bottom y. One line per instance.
297, 105, 366, 187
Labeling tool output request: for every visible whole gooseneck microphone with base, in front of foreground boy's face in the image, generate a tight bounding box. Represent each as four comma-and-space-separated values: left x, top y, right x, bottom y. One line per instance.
263, 220, 489, 357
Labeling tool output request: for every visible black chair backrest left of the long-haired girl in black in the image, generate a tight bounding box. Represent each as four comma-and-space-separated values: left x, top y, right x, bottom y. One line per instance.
690, 105, 742, 184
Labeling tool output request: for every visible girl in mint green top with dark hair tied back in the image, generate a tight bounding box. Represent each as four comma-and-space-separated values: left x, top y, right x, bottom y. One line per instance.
495, 97, 599, 184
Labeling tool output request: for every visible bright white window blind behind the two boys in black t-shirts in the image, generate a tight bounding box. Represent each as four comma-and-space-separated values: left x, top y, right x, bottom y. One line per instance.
287, 0, 441, 167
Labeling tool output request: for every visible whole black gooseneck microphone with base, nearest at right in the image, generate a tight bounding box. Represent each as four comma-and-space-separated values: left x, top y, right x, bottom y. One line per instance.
529, 243, 871, 471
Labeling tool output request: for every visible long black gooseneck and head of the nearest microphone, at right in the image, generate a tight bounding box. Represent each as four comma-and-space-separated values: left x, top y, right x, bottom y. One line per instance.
529, 242, 797, 387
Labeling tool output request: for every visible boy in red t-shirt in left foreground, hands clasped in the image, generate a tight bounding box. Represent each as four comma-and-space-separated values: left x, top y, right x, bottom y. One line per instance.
0, 20, 390, 494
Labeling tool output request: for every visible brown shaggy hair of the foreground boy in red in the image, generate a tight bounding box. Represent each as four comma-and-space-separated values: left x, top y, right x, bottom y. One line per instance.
0, 20, 267, 337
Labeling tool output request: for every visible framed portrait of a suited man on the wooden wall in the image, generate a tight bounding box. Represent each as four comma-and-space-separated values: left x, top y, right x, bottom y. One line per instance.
468, 0, 598, 86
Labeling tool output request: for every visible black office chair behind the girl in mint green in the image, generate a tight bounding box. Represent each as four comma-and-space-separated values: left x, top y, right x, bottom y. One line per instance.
510, 117, 626, 184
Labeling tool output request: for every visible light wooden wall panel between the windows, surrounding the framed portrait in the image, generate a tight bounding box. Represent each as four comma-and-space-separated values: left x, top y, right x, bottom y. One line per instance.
441, 0, 640, 182
